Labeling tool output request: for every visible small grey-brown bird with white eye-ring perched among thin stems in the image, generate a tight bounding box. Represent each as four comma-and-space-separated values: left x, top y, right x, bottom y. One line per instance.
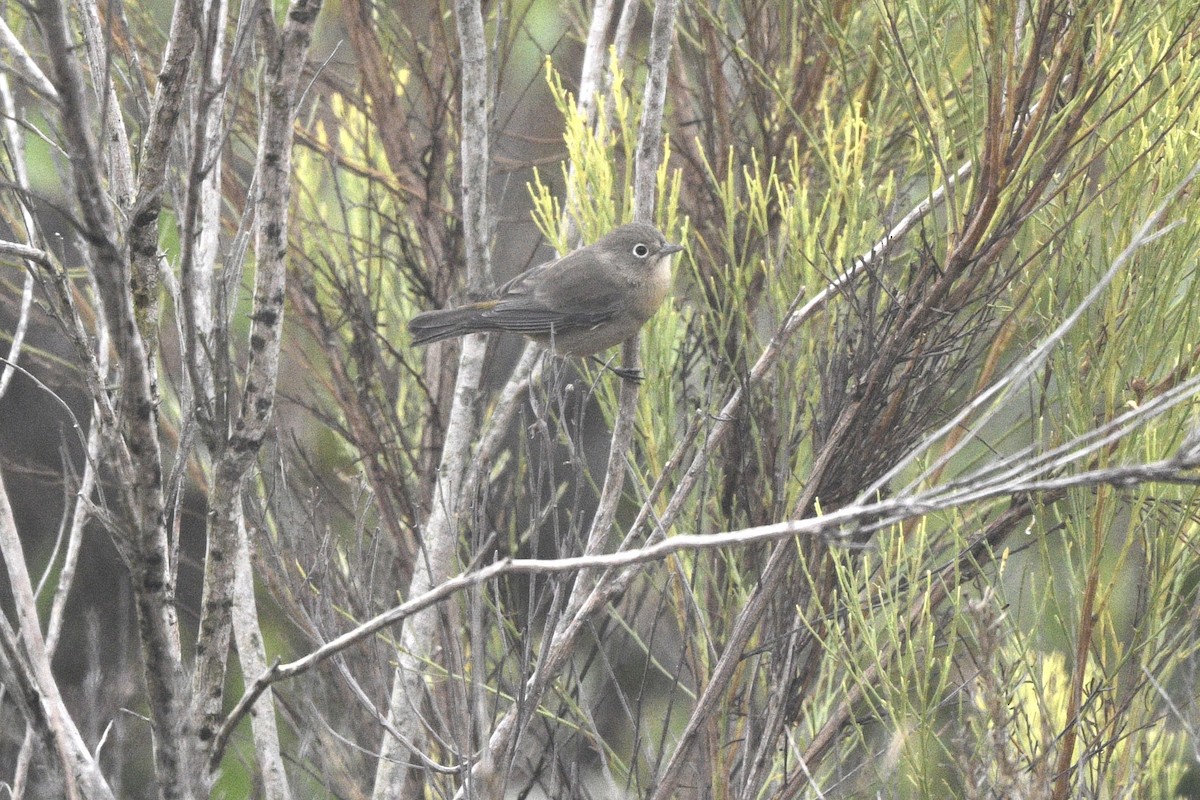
408, 222, 683, 374
